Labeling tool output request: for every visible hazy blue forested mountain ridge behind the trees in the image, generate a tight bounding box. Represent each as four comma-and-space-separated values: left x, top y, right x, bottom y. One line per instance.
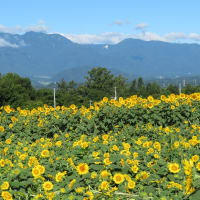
0, 32, 200, 81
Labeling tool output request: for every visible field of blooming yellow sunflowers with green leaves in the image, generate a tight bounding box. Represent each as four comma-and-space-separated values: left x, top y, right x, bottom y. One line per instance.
0, 93, 200, 200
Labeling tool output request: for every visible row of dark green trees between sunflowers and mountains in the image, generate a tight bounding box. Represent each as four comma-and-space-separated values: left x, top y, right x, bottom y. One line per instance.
0, 67, 200, 109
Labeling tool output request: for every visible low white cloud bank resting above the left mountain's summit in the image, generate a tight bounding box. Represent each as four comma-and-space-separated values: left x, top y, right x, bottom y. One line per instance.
0, 21, 48, 34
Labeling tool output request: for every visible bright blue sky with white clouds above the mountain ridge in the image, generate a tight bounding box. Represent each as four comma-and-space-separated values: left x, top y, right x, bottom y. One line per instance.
0, 0, 200, 43
